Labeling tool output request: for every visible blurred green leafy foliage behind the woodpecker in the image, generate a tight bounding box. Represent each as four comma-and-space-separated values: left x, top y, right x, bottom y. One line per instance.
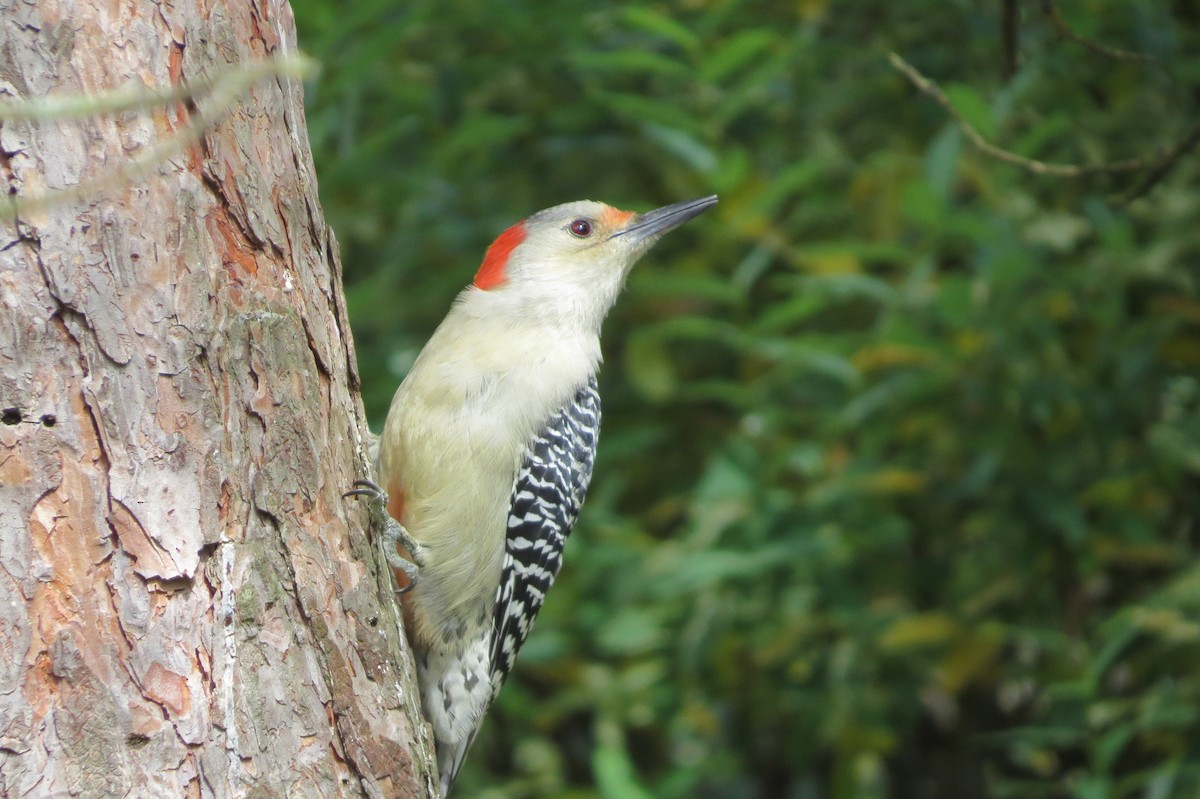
293, 0, 1200, 799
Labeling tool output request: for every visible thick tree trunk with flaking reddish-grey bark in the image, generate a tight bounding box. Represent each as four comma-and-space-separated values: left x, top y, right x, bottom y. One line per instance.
0, 0, 436, 797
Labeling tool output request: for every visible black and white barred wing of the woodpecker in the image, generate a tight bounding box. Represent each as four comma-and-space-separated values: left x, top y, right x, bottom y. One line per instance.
492, 376, 600, 698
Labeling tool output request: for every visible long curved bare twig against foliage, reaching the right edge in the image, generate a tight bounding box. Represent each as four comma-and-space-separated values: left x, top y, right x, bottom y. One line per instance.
888, 53, 1200, 184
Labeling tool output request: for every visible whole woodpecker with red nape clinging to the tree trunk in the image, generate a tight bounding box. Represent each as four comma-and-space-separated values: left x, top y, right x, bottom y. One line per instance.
350, 196, 716, 795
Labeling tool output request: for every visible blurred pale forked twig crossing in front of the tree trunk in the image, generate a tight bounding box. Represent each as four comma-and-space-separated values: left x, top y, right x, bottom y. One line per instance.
0, 55, 317, 220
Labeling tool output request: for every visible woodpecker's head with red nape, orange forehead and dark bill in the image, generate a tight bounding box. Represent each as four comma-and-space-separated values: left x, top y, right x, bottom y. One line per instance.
467, 194, 716, 328
